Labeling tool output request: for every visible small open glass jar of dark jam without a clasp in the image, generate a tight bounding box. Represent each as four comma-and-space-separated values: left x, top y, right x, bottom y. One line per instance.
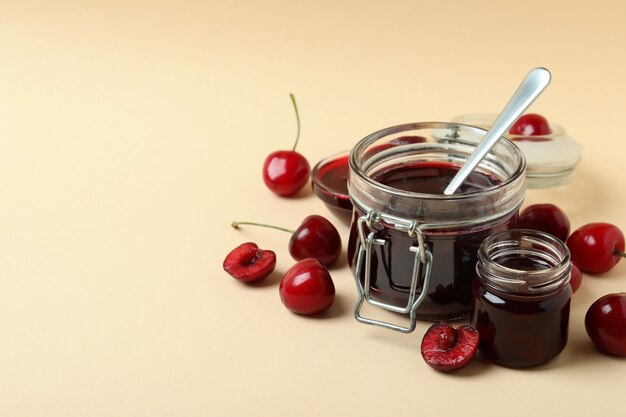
470, 229, 572, 368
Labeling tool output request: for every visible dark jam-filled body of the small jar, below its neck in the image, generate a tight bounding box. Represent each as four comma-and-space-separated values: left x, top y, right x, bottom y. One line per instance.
470, 278, 572, 368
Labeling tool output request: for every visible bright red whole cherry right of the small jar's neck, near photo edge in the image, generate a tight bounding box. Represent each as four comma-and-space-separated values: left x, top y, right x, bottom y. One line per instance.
567, 223, 624, 274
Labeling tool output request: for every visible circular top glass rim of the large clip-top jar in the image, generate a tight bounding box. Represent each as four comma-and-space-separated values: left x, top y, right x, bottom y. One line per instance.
348, 122, 526, 201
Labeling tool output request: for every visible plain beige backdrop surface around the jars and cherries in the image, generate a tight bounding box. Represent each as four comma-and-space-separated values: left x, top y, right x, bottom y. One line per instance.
0, 0, 626, 417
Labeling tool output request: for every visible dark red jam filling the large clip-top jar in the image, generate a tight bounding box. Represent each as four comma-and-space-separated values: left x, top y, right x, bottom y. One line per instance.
348, 162, 517, 321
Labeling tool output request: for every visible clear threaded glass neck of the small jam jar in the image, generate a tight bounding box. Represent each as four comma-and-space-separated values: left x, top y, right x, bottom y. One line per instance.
476, 229, 571, 295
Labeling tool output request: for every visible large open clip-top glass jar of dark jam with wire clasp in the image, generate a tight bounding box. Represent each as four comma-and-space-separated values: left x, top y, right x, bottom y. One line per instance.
348, 123, 526, 332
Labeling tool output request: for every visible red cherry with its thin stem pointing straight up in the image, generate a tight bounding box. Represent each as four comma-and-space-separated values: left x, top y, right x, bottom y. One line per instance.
263, 94, 311, 197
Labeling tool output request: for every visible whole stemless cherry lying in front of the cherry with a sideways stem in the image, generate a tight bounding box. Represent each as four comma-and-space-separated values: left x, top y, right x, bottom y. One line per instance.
278, 258, 335, 315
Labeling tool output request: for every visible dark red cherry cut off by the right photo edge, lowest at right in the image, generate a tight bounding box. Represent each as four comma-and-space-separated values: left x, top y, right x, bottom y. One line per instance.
585, 292, 626, 356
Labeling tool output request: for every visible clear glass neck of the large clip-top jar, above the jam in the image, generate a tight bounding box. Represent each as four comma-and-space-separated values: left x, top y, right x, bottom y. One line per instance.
348, 123, 526, 225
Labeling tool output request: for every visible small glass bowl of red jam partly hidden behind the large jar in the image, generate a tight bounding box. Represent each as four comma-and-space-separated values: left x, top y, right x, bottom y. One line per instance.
313, 155, 352, 210
